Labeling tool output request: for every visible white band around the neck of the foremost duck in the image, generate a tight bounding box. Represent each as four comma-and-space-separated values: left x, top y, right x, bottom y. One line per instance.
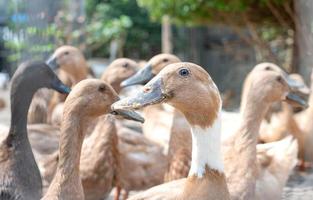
189, 112, 224, 178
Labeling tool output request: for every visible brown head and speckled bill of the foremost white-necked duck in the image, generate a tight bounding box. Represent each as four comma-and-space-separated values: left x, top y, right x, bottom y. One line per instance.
112, 62, 221, 127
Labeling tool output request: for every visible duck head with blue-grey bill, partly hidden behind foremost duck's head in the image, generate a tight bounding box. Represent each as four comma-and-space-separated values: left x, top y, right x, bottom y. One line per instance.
121, 54, 180, 87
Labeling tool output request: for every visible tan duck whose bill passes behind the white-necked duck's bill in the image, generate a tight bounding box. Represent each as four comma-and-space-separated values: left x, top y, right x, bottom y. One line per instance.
42, 79, 143, 200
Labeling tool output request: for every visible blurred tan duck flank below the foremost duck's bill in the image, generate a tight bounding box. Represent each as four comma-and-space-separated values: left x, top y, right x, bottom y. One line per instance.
118, 127, 167, 191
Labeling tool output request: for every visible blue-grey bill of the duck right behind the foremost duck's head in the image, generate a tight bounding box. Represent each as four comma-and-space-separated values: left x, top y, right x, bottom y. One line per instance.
121, 64, 155, 87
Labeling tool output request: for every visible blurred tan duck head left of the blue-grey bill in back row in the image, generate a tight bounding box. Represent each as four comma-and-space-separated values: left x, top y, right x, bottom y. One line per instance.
101, 58, 138, 93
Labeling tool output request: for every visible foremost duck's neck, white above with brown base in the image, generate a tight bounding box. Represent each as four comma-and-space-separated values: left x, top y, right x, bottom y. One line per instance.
182, 112, 229, 199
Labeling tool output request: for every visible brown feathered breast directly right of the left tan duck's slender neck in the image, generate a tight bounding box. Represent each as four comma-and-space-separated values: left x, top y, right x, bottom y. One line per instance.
80, 115, 121, 200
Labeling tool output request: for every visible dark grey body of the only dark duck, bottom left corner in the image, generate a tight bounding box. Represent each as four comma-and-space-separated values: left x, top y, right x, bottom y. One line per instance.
0, 134, 42, 200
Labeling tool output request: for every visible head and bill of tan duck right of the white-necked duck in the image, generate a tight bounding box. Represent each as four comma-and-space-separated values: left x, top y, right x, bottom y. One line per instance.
248, 70, 308, 108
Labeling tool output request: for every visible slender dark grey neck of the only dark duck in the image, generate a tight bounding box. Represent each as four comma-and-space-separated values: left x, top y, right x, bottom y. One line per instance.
8, 82, 36, 143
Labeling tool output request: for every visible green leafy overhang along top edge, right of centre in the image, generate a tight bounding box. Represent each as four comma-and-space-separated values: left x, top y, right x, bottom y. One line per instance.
138, 0, 291, 25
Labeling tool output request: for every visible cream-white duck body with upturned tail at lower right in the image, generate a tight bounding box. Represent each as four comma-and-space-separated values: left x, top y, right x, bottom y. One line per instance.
256, 135, 298, 199
